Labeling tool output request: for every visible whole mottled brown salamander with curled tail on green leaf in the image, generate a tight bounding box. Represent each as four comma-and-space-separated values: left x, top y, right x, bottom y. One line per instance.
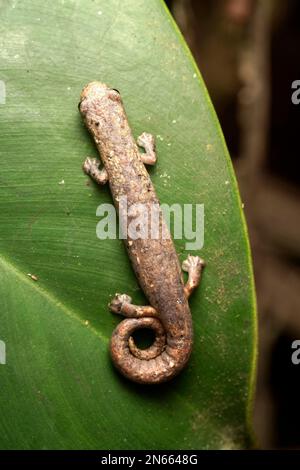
79, 82, 204, 384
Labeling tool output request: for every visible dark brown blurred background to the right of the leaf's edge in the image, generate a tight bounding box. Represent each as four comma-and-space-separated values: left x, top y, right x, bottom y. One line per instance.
166, 0, 300, 448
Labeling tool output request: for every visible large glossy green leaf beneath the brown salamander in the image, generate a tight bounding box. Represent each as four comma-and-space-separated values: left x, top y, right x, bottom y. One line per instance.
0, 0, 256, 449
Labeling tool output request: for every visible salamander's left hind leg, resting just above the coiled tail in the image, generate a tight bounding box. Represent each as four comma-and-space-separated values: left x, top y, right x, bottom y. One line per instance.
108, 294, 157, 318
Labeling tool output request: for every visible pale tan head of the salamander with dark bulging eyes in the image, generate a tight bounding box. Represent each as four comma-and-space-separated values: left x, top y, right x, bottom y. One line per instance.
78, 82, 121, 114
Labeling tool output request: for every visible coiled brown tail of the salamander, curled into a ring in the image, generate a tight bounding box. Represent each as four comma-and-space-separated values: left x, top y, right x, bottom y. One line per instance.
110, 317, 192, 384
